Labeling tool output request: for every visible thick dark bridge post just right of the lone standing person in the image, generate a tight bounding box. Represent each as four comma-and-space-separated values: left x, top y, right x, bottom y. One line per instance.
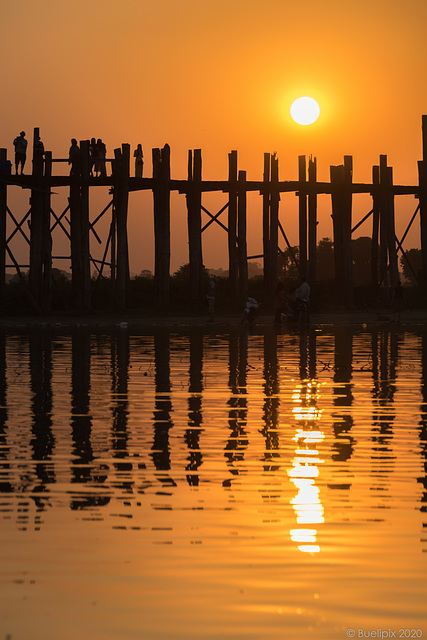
153, 144, 170, 308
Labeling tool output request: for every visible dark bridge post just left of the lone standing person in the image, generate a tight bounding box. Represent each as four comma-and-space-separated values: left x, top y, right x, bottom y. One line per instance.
114, 144, 130, 308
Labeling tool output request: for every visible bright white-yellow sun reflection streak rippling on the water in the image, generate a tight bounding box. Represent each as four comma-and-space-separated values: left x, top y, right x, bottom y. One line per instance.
288, 380, 325, 553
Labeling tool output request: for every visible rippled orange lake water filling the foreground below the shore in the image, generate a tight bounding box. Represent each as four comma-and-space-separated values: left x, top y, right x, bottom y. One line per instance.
0, 327, 427, 640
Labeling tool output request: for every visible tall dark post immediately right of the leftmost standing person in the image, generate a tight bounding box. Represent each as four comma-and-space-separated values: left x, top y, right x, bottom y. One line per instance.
29, 127, 44, 308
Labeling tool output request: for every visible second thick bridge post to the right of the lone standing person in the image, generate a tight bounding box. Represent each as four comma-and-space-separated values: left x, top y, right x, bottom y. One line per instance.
187, 149, 203, 303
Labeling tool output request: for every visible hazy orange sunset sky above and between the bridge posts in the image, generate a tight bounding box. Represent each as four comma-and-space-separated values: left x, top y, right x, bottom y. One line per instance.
0, 0, 427, 272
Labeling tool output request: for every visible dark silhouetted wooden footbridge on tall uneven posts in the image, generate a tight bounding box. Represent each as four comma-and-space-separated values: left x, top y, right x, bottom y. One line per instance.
0, 116, 427, 313
